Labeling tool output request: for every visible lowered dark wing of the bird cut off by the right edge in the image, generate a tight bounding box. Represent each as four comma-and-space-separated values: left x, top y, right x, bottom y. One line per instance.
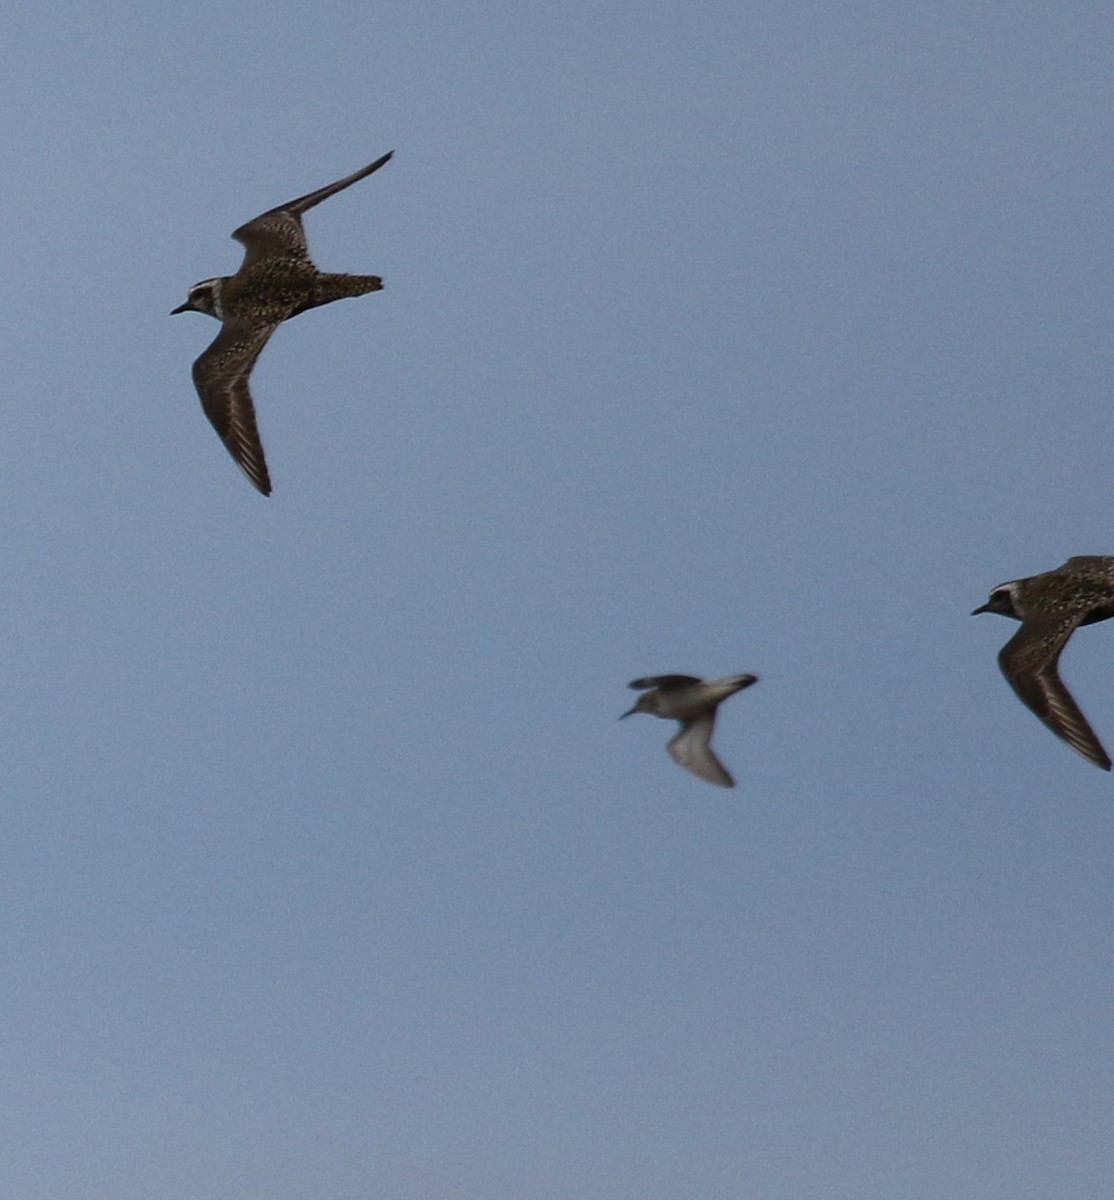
998, 614, 1110, 770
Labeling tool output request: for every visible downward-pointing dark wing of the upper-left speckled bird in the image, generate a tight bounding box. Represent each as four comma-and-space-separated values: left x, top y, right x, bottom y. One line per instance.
193, 322, 275, 496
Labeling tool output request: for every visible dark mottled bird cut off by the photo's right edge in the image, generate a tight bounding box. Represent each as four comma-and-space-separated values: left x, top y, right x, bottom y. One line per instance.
972, 556, 1114, 770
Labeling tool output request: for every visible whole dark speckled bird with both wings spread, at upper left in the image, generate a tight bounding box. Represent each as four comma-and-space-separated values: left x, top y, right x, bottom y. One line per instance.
172, 151, 394, 496
